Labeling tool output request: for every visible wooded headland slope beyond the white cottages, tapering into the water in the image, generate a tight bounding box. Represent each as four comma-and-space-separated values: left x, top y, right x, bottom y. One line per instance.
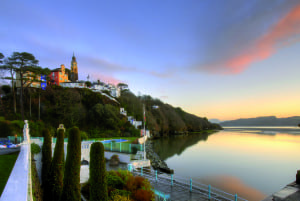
119, 91, 222, 137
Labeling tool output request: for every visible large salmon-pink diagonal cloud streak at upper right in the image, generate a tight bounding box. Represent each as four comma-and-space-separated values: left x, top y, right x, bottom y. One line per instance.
207, 5, 300, 74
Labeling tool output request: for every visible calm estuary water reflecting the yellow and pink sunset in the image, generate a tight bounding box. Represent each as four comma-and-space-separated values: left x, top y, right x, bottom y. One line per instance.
155, 127, 300, 200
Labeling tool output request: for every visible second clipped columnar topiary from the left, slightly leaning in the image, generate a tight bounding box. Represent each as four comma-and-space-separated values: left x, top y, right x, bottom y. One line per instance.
44, 129, 64, 201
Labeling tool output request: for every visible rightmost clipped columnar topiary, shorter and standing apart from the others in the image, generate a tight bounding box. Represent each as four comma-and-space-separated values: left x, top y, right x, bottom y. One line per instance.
90, 142, 108, 201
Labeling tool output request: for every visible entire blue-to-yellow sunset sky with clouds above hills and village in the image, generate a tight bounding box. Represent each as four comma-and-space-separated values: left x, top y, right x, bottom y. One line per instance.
0, 0, 300, 120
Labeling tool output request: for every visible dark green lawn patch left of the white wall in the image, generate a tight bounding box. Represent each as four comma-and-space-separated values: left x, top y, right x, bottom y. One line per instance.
0, 152, 19, 195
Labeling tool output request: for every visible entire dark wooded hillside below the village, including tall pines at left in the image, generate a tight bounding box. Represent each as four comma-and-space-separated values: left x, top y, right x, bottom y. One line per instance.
0, 52, 221, 137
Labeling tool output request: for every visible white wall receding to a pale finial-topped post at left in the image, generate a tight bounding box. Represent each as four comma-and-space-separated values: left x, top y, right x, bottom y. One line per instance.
0, 120, 33, 201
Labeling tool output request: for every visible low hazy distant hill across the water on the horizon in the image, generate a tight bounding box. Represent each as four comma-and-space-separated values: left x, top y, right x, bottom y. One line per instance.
220, 116, 300, 126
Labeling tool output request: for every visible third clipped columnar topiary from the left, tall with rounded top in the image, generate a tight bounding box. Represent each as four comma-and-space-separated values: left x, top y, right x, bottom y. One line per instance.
61, 127, 81, 201
